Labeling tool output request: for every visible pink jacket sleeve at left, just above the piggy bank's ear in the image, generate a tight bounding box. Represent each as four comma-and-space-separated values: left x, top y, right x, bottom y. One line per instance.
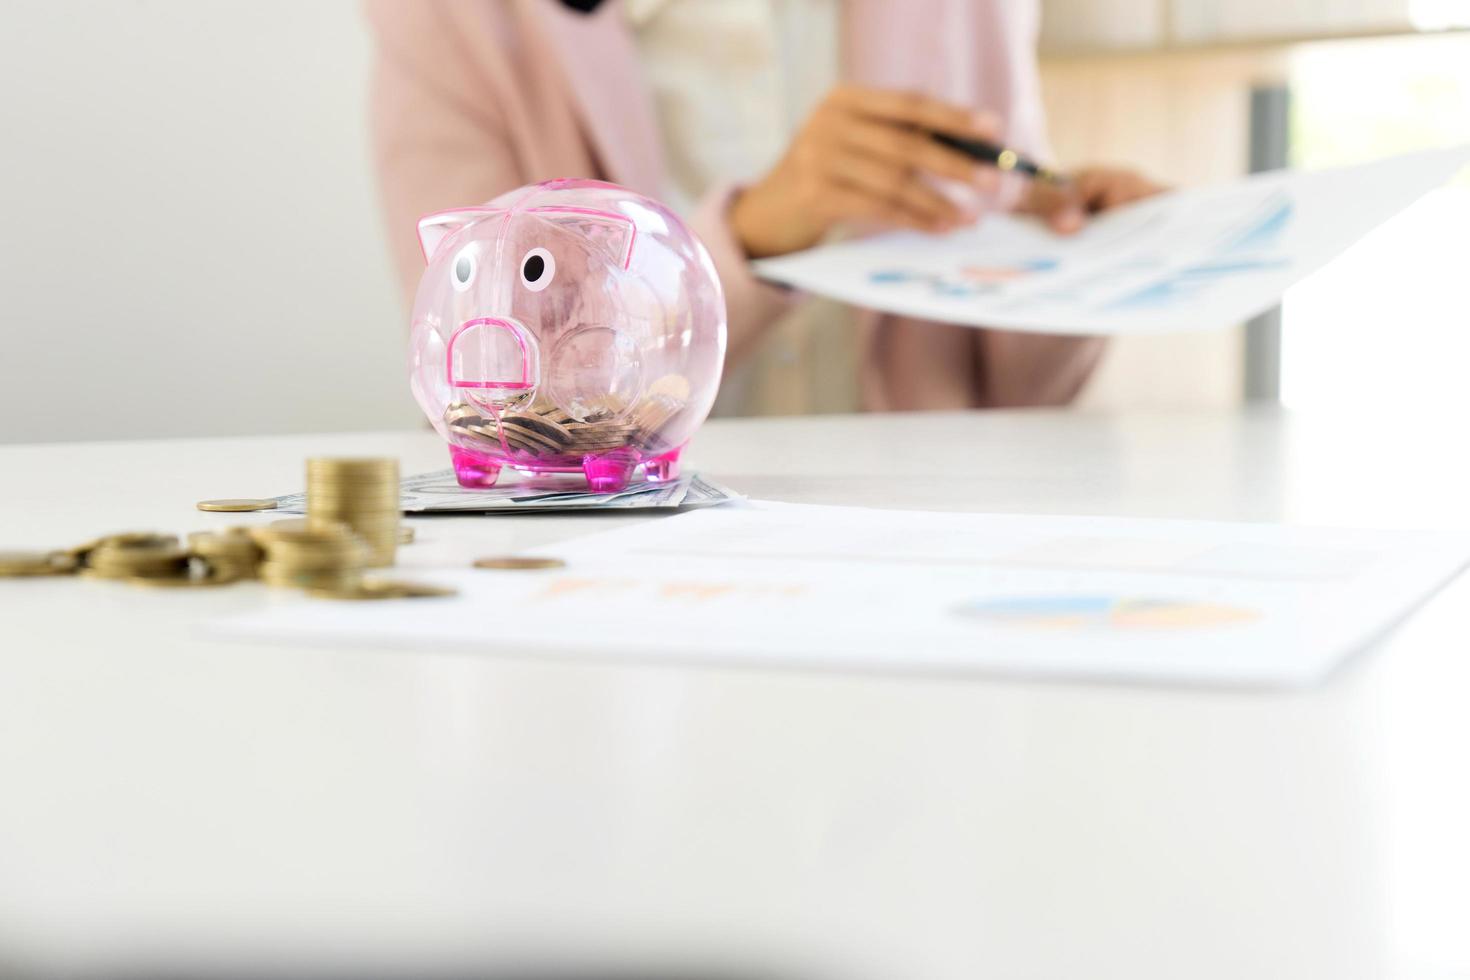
365, 0, 525, 297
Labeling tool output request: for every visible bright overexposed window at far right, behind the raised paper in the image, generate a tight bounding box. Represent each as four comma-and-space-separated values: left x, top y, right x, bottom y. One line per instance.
1282, 35, 1470, 413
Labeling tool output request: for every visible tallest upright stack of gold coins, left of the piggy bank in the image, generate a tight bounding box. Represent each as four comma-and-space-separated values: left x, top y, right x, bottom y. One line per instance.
304, 457, 398, 567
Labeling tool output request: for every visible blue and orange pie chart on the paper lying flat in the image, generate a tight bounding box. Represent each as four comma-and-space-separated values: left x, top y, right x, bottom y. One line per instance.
956, 595, 1260, 633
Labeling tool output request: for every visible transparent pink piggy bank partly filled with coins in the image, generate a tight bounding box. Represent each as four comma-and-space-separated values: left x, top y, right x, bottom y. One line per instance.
410, 181, 725, 492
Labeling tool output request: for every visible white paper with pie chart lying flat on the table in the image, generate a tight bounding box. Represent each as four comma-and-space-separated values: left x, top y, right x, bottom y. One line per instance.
216, 502, 1470, 686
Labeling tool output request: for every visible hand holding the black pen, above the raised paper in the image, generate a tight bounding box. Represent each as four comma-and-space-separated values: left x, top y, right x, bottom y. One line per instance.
729, 85, 1000, 259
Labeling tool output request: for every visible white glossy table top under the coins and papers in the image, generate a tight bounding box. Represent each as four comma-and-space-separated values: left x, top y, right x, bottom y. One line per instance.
0, 411, 1470, 980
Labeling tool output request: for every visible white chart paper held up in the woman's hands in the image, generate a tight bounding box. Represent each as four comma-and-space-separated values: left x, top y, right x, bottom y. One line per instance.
754, 147, 1470, 334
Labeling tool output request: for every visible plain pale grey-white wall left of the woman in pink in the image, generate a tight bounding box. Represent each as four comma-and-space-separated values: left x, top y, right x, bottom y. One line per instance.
0, 0, 420, 442
